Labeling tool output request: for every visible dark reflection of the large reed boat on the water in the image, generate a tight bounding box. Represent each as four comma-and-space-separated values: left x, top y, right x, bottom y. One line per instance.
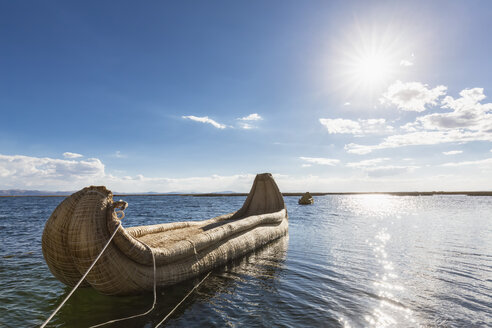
46, 236, 289, 327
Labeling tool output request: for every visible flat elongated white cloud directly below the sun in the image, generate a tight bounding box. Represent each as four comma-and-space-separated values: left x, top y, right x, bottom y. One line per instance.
319, 118, 393, 135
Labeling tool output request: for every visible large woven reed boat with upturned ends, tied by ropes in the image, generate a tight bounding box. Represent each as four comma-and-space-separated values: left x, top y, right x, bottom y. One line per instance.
42, 173, 288, 295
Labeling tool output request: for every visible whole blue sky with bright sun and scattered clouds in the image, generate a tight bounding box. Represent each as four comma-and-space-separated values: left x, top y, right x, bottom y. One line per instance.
0, 1, 492, 192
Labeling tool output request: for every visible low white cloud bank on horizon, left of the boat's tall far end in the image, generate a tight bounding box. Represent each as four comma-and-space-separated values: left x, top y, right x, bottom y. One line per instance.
0, 154, 262, 192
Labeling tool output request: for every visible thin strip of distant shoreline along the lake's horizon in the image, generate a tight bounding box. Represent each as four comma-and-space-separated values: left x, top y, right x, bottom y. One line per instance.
0, 191, 492, 198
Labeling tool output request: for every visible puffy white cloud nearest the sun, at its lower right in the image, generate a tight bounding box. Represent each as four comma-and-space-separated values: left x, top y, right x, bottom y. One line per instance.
380, 81, 447, 112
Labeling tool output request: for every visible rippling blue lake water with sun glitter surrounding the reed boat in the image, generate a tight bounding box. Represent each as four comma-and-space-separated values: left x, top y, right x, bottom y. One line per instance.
0, 195, 492, 327
